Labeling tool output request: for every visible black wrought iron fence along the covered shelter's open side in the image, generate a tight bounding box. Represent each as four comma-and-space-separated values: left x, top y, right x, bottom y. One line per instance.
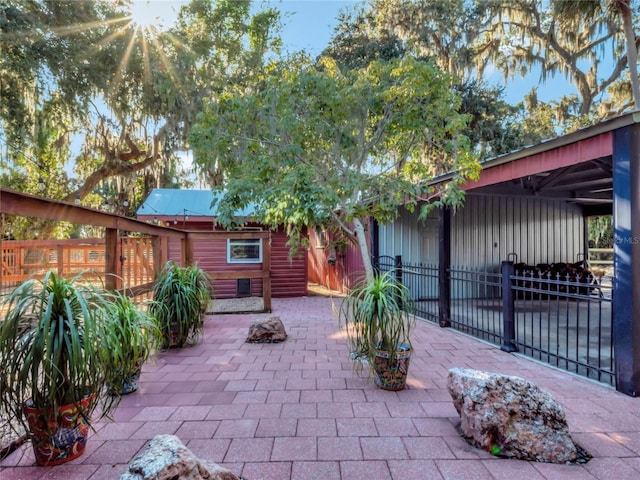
375, 256, 615, 385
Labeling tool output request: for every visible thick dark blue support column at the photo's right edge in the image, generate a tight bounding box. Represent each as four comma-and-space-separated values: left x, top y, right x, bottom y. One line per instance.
612, 124, 640, 397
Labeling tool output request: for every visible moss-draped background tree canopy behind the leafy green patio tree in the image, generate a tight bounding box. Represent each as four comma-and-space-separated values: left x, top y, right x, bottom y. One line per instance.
0, 0, 640, 242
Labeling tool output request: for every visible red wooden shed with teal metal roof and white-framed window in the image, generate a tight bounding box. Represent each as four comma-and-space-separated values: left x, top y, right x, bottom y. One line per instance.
136, 188, 307, 299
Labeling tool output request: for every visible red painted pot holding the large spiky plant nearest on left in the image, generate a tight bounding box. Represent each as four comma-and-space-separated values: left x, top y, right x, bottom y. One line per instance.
24, 395, 95, 466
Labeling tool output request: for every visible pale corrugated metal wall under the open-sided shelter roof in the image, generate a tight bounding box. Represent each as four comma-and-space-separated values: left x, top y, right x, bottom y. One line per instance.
380, 195, 584, 270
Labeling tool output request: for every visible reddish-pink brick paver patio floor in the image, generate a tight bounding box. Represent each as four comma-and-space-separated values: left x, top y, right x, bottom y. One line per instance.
0, 296, 640, 480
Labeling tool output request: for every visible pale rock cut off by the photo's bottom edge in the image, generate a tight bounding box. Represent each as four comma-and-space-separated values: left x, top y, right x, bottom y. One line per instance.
120, 435, 242, 480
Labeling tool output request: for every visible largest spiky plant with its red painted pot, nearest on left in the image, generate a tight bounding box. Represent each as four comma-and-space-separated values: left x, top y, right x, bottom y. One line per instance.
0, 272, 125, 465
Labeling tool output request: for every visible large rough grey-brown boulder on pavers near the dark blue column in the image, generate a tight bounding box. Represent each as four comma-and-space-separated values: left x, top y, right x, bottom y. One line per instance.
447, 368, 579, 463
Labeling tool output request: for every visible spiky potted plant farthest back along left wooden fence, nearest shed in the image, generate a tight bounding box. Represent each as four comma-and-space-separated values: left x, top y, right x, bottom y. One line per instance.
150, 261, 212, 348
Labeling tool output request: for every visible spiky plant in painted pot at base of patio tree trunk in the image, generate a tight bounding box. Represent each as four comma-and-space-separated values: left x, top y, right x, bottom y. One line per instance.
340, 271, 415, 390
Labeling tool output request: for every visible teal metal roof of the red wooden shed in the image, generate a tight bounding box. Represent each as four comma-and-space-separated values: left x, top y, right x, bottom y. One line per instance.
136, 188, 253, 217
